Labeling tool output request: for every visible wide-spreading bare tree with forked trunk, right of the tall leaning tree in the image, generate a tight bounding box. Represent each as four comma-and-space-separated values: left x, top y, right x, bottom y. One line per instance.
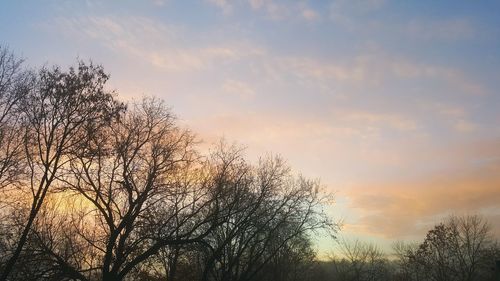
52, 100, 221, 280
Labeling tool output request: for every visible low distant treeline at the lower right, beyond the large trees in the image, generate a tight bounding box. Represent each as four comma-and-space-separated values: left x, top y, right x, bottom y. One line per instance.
310, 215, 500, 281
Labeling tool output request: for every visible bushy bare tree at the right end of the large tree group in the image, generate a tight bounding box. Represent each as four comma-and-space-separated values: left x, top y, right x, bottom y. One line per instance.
197, 147, 337, 281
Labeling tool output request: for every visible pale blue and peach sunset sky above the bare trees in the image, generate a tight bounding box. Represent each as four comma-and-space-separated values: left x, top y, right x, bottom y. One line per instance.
0, 0, 500, 251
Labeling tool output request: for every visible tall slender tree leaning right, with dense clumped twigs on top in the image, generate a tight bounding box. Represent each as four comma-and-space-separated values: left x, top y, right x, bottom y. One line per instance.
0, 62, 123, 280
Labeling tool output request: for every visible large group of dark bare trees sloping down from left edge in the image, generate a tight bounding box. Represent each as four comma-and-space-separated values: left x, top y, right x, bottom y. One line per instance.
0, 48, 338, 281
